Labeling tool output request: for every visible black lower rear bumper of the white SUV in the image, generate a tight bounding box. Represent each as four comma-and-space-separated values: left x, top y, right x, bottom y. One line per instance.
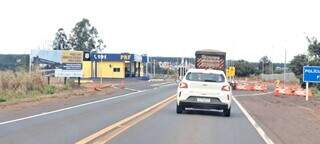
179, 101, 229, 110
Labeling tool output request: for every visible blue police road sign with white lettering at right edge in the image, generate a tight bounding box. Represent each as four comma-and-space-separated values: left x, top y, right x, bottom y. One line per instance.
303, 66, 320, 83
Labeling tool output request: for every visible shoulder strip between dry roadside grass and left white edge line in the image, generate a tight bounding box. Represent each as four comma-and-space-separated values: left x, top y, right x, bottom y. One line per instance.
0, 83, 132, 122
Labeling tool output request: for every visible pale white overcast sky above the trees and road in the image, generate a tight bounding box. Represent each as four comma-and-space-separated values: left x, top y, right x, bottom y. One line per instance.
0, 0, 320, 62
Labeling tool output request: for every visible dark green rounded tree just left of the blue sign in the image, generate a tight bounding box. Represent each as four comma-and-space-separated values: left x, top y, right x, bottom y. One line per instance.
289, 54, 308, 84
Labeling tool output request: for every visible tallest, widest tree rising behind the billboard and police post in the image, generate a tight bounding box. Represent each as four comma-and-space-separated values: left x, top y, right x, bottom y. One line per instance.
69, 18, 106, 51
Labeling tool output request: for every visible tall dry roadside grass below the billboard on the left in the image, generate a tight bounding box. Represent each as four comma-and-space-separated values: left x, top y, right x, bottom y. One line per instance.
0, 71, 75, 104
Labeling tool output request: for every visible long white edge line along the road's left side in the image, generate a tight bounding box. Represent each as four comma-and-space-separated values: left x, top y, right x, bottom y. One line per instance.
0, 91, 144, 126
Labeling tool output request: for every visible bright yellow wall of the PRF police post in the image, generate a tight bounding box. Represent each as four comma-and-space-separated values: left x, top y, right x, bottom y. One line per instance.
96, 61, 125, 78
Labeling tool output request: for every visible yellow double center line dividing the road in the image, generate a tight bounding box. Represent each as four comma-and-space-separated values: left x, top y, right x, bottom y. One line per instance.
76, 95, 176, 144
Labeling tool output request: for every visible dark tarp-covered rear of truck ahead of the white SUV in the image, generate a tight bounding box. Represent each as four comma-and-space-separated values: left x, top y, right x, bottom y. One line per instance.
196, 49, 226, 70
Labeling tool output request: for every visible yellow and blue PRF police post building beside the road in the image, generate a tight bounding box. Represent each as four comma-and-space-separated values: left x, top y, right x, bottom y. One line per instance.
83, 53, 147, 78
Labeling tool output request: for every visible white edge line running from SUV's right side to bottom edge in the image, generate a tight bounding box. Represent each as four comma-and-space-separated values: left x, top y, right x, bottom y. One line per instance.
232, 97, 274, 144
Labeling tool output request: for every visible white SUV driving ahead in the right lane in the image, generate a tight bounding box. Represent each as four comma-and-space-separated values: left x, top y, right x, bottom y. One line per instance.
177, 69, 232, 116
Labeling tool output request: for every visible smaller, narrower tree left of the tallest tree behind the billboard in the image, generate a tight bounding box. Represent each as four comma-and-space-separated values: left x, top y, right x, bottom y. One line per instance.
52, 28, 70, 50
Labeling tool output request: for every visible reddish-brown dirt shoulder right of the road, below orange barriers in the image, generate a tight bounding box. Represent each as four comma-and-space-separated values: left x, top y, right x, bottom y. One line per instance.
236, 94, 320, 144
